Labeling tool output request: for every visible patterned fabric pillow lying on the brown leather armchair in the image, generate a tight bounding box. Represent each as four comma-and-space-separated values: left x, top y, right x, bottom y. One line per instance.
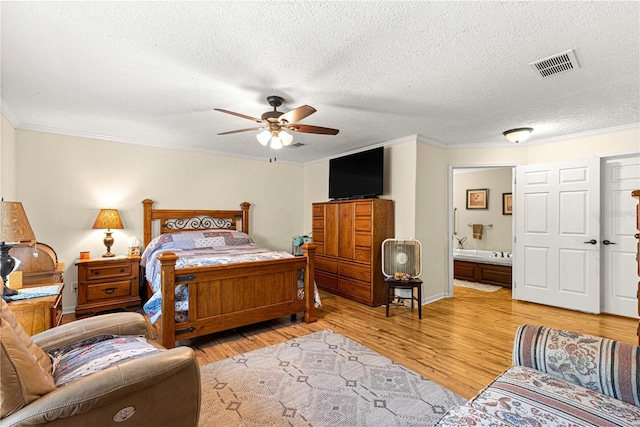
53, 335, 164, 387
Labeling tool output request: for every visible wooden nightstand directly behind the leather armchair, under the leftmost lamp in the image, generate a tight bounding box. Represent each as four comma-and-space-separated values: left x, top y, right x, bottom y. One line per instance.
7, 283, 64, 335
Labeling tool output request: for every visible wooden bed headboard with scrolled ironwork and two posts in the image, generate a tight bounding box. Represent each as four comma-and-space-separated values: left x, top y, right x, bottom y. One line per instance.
142, 199, 251, 246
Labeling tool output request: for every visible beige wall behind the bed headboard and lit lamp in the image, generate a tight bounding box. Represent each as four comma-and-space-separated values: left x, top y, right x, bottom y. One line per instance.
16, 130, 304, 311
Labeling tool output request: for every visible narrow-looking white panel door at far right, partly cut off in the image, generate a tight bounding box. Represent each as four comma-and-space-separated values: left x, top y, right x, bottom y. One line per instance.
601, 155, 640, 318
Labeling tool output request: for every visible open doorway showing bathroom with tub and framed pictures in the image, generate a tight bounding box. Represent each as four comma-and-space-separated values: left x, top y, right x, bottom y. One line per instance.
449, 165, 515, 296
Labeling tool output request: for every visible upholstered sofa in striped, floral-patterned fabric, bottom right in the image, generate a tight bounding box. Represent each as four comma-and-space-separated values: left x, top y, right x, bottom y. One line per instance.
438, 325, 640, 427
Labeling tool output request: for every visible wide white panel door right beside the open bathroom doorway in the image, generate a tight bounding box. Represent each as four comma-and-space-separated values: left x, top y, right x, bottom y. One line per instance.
514, 159, 600, 313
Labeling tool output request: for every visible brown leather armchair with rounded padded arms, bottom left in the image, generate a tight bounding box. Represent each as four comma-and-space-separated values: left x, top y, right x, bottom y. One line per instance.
0, 301, 200, 427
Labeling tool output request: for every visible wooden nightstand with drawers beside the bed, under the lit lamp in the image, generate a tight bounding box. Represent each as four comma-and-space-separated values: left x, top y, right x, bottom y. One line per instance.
76, 257, 141, 319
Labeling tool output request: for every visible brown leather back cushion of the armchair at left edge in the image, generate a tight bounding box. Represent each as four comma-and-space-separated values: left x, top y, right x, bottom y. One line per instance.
0, 320, 56, 418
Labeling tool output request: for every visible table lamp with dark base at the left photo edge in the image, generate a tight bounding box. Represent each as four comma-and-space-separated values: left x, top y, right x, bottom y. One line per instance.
0, 200, 36, 296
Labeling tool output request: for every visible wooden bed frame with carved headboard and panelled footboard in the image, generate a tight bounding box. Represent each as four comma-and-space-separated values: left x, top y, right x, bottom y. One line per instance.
142, 199, 316, 348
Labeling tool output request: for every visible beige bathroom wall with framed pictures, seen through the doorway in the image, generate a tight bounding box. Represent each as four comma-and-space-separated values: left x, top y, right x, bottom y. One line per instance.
453, 167, 513, 252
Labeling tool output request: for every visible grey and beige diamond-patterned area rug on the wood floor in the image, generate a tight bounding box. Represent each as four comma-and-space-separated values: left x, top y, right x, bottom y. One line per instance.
199, 329, 465, 427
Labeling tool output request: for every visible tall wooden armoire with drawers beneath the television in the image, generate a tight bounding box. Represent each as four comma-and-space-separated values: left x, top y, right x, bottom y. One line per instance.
313, 199, 394, 306
